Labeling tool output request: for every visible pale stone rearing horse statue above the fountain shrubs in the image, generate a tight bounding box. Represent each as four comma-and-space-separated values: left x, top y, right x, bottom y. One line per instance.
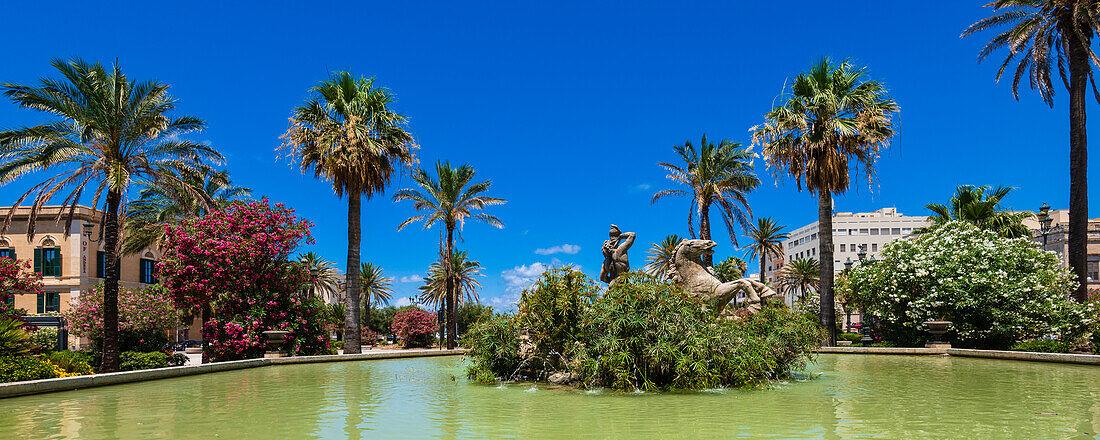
669, 240, 776, 316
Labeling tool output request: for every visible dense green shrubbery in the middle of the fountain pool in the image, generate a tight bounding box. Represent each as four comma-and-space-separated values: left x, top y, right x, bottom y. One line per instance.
465, 268, 822, 391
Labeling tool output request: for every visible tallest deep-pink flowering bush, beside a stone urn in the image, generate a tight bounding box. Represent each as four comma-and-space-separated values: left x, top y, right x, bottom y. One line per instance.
158, 199, 331, 361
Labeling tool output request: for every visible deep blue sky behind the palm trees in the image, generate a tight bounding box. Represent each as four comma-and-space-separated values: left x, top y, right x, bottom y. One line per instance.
0, 0, 1100, 305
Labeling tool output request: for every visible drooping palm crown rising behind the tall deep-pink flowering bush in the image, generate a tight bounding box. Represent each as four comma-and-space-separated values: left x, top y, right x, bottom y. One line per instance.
122, 167, 251, 255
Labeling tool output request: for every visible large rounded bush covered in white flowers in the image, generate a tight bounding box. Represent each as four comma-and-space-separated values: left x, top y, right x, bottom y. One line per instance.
839, 221, 1097, 349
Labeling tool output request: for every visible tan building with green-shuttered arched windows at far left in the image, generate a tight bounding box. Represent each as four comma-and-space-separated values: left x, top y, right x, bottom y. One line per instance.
0, 206, 201, 345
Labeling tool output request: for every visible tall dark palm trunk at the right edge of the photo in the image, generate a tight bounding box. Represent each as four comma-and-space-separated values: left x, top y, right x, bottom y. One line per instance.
1064, 24, 1092, 303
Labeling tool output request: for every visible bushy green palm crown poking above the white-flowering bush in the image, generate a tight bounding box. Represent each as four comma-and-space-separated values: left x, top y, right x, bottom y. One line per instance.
916, 185, 1033, 239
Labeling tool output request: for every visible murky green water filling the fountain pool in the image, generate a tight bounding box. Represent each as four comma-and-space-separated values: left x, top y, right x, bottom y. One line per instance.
0, 355, 1100, 439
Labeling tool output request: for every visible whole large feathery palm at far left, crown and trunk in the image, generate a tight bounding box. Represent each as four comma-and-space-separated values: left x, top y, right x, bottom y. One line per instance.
0, 58, 222, 373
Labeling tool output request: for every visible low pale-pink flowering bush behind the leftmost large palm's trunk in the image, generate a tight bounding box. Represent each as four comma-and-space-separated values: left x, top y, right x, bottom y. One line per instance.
65, 284, 179, 339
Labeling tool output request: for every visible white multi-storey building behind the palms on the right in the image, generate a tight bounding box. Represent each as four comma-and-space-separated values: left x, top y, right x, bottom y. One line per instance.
765, 208, 928, 305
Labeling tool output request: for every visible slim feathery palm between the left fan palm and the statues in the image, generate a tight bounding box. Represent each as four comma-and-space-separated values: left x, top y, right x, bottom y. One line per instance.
394, 162, 506, 349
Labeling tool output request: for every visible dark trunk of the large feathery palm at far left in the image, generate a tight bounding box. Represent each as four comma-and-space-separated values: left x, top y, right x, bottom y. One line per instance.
99, 189, 122, 373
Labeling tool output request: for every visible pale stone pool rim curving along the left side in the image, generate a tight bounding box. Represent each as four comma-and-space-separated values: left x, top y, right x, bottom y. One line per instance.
0, 349, 466, 398
